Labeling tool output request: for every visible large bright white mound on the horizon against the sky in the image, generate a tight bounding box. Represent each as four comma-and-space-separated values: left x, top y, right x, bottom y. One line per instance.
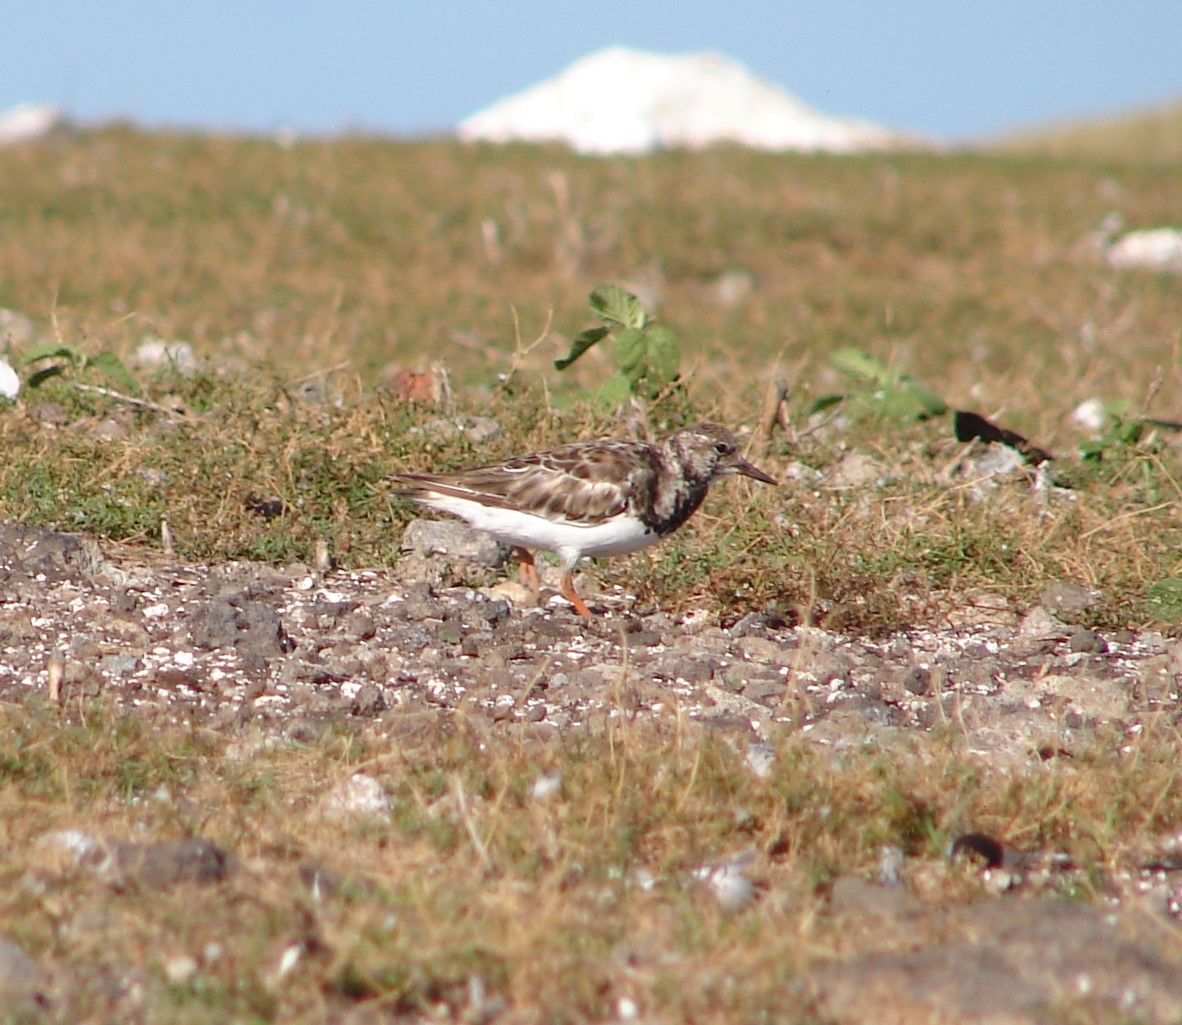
459, 46, 917, 154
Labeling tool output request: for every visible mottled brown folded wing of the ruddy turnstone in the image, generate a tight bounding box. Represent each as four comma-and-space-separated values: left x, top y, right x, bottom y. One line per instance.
395, 442, 657, 524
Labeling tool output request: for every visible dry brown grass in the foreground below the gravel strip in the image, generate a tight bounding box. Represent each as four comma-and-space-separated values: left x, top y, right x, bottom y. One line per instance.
0, 705, 1182, 1021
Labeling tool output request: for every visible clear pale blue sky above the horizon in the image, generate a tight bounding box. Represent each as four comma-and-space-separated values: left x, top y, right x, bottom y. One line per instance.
9, 0, 1182, 141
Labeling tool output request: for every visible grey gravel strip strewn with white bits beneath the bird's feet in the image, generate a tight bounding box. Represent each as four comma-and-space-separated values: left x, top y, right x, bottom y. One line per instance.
0, 523, 1182, 760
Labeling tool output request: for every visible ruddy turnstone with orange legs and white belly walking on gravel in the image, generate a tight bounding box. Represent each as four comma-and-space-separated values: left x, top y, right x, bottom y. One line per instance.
394, 423, 775, 616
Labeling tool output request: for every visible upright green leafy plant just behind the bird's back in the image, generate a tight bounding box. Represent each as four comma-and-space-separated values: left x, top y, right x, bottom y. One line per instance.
554, 285, 681, 406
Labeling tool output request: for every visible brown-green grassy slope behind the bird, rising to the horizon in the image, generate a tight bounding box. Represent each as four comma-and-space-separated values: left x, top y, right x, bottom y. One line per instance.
0, 129, 1182, 629
